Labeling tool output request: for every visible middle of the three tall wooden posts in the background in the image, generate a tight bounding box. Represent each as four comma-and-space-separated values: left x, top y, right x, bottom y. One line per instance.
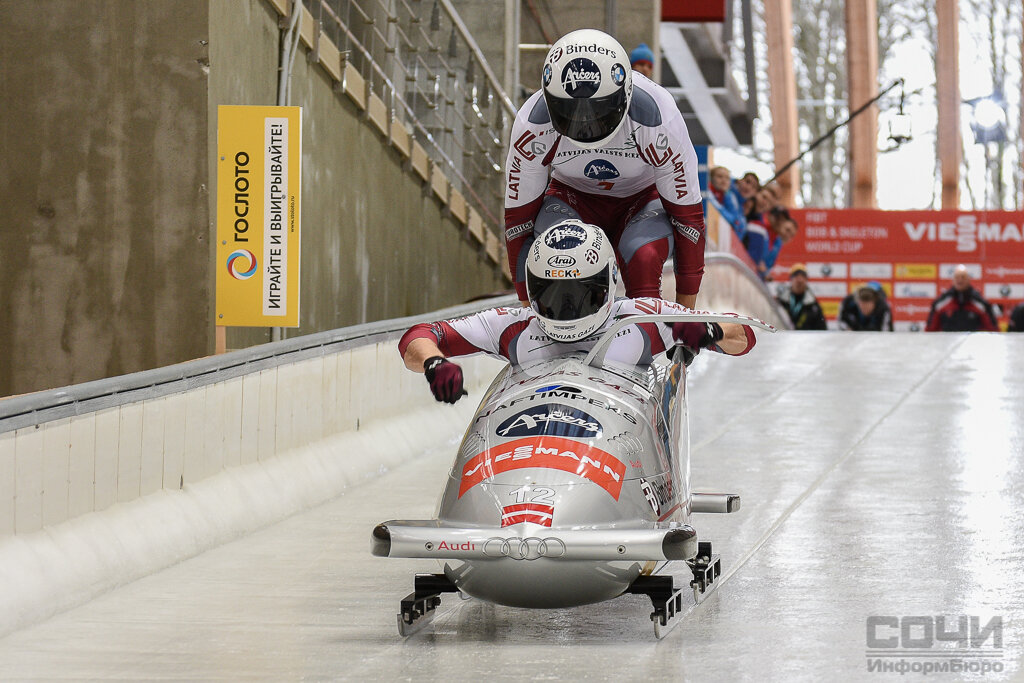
846, 0, 879, 209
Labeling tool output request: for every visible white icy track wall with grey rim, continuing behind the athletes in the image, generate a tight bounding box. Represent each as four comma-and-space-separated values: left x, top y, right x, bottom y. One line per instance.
0, 255, 778, 636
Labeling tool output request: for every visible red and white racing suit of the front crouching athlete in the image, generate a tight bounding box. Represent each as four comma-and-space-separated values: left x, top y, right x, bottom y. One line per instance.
398, 299, 755, 366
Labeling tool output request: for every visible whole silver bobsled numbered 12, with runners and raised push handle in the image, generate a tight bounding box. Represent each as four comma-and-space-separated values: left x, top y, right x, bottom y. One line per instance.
371, 312, 774, 638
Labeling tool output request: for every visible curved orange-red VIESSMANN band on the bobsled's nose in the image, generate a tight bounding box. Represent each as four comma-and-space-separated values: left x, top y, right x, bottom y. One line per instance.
459, 436, 626, 501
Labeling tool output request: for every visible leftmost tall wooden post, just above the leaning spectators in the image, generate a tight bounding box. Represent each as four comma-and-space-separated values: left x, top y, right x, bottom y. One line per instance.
765, 0, 800, 206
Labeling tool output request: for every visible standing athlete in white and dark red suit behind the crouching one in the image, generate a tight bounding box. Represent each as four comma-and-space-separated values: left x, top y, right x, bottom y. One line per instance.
505, 29, 705, 308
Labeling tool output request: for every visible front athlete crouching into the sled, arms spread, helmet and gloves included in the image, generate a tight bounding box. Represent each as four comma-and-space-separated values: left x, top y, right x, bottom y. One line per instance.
398, 219, 756, 403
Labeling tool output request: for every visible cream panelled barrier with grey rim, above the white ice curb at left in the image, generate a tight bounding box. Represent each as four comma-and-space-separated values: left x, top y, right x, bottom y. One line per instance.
0, 297, 514, 538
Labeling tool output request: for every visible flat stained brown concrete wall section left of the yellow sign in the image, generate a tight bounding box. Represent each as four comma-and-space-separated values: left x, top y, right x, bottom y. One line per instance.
0, 0, 212, 395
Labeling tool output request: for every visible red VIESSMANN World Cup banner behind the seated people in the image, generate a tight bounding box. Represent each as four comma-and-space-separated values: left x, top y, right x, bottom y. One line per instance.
771, 209, 1024, 330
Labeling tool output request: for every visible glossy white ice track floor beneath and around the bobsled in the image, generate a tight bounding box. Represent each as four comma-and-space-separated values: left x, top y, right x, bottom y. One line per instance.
0, 332, 1024, 681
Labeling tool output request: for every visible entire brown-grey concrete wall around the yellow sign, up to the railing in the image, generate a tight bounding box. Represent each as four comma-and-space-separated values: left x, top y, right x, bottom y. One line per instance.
0, 0, 506, 395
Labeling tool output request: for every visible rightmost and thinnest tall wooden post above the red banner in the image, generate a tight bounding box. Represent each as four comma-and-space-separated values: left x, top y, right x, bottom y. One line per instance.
935, 0, 961, 209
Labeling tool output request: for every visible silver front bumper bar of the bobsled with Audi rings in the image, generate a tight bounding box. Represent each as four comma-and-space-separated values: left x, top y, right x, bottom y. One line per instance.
370, 519, 697, 562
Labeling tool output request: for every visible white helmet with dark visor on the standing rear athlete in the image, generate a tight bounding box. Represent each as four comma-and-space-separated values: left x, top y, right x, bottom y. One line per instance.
542, 29, 633, 147
